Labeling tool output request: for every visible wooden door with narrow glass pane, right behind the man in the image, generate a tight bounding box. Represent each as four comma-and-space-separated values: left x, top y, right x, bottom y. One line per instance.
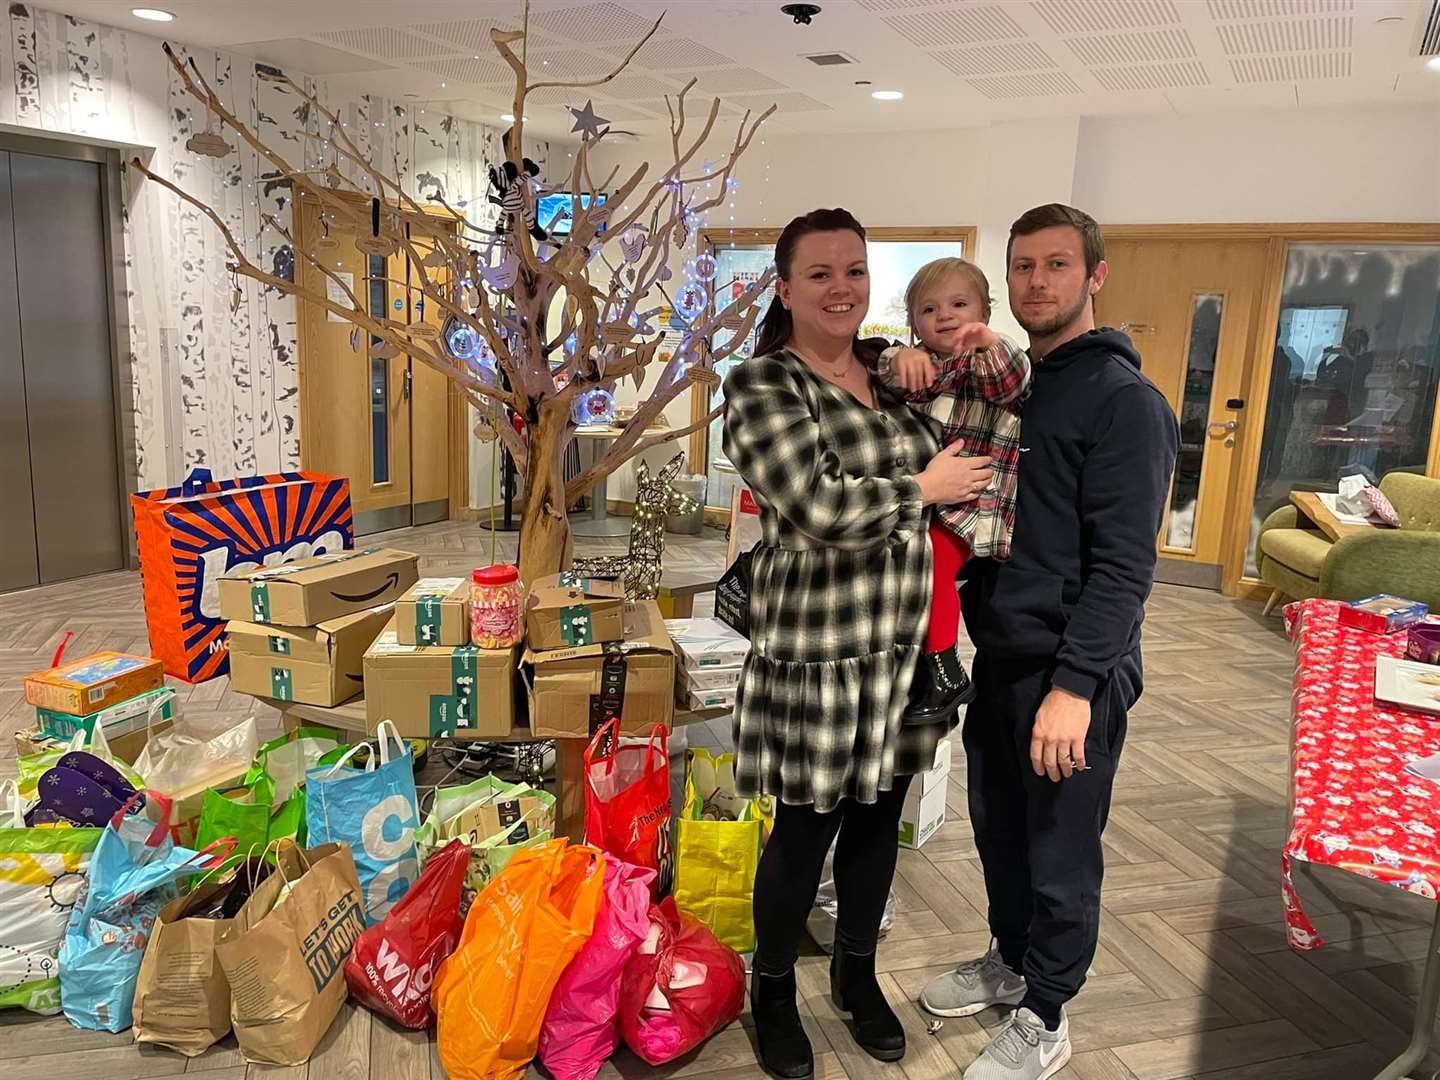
1096, 238, 1267, 589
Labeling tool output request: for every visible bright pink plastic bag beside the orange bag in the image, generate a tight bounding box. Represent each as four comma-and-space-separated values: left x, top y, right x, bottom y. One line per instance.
540, 855, 655, 1080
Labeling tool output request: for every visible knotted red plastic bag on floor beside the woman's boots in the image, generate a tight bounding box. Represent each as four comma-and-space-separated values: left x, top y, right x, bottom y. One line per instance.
621, 897, 744, 1066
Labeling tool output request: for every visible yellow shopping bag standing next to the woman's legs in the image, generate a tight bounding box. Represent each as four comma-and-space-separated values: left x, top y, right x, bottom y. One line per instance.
675, 750, 765, 952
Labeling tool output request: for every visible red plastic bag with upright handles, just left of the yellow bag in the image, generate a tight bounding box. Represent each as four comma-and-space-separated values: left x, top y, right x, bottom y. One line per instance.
585, 720, 675, 900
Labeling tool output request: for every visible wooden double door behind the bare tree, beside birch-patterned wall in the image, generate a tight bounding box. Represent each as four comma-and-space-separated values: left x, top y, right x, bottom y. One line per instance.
297, 200, 465, 533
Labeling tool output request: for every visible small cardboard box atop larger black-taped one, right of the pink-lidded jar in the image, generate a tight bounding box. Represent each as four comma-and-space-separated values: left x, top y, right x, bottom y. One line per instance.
523, 572, 675, 739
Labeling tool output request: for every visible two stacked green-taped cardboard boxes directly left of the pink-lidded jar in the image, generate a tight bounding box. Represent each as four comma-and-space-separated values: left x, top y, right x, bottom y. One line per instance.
364, 577, 518, 739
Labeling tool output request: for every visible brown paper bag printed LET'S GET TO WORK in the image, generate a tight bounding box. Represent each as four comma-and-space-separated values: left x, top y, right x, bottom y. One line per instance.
215, 844, 364, 1066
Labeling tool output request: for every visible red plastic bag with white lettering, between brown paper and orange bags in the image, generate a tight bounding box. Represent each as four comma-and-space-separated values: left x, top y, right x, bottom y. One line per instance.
346, 840, 469, 1031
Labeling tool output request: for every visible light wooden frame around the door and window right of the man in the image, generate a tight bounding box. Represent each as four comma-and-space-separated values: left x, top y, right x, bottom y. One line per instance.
1100, 222, 1440, 599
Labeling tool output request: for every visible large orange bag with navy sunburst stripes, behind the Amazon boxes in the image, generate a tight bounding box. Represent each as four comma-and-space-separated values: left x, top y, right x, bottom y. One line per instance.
130, 469, 354, 683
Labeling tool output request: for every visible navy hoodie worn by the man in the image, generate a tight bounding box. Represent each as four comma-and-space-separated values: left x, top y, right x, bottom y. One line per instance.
962, 330, 1179, 707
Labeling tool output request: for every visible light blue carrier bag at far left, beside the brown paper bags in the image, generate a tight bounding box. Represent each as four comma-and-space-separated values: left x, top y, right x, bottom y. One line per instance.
60, 792, 224, 1031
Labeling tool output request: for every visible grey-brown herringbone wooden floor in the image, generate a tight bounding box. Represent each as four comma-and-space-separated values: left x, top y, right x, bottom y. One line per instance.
0, 524, 1433, 1080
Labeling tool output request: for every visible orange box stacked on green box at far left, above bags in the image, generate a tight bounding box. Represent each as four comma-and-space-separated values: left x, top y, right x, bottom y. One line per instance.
14, 652, 174, 762
